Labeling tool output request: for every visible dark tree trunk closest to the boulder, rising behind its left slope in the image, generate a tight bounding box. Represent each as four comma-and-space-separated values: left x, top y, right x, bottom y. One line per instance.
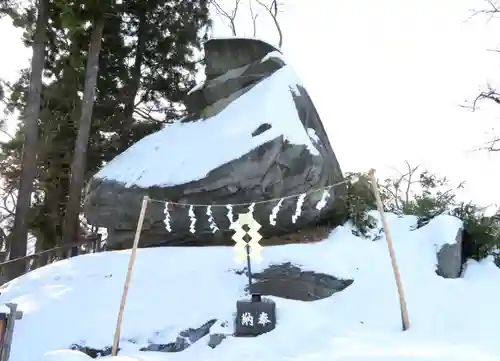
120, 3, 148, 150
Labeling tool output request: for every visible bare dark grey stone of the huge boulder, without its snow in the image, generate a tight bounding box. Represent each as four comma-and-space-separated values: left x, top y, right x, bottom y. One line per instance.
84, 39, 346, 249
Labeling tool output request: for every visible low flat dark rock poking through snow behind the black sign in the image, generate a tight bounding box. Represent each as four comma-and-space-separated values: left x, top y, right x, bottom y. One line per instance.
251, 263, 353, 301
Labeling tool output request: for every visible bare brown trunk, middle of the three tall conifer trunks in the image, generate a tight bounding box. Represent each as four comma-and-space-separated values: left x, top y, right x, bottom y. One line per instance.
63, 15, 104, 250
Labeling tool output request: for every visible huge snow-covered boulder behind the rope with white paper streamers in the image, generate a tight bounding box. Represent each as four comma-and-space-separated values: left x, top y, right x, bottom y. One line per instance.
85, 38, 346, 248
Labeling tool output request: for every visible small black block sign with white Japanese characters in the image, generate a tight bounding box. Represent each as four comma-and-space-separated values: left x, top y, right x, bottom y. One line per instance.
235, 297, 276, 336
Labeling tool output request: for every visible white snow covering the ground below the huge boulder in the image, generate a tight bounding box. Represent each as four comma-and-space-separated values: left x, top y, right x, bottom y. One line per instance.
0, 214, 500, 361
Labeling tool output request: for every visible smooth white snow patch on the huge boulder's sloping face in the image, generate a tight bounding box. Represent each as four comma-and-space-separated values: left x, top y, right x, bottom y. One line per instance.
95, 56, 319, 187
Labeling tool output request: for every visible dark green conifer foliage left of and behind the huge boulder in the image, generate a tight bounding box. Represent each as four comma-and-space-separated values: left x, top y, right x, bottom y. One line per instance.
0, 0, 211, 272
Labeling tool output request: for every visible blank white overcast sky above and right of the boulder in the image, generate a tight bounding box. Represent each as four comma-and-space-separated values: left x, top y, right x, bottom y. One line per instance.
0, 0, 500, 205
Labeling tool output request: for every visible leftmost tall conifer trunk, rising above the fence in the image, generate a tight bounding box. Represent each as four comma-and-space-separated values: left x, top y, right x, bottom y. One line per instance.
8, 0, 48, 279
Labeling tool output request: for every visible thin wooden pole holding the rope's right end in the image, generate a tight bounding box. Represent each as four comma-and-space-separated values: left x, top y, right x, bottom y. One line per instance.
369, 169, 410, 331
